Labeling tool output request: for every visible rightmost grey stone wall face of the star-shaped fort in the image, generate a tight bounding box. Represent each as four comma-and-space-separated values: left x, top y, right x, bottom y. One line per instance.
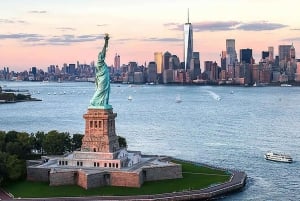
143, 164, 182, 181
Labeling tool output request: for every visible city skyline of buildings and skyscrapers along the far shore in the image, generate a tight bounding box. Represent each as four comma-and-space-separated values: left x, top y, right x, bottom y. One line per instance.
0, 11, 300, 86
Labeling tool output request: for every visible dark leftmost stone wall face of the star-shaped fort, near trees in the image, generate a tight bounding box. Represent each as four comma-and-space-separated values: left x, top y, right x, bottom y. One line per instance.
27, 167, 50, 182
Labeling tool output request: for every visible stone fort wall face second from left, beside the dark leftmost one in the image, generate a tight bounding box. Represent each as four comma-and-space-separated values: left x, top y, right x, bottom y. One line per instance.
49, 170, 78, 186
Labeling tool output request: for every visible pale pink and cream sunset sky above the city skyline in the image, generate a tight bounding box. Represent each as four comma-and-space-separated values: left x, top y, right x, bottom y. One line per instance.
0, 0, 300, 71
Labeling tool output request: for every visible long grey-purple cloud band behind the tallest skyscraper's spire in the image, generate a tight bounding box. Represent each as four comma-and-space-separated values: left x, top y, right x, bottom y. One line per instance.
164, 21, 287, 32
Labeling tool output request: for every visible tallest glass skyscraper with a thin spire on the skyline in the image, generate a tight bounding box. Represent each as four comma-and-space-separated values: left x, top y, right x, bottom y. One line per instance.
184, 10, 193, 70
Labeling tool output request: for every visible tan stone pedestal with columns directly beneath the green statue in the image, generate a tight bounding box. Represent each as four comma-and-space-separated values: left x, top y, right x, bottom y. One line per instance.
81, 109, 120, 153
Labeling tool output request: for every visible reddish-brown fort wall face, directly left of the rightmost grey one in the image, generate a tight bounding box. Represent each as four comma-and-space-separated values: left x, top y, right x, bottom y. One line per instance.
110, 171, 143, 188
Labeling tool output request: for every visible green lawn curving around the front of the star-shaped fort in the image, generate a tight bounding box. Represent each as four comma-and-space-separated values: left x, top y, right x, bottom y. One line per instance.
5, 161, 230, 198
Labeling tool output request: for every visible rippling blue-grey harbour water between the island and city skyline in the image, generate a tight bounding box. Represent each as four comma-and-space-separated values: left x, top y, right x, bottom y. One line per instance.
0, 82, 300, 200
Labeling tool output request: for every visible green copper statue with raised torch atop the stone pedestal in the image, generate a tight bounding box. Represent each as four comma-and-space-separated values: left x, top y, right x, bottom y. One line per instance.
89, 34, 112, 109
